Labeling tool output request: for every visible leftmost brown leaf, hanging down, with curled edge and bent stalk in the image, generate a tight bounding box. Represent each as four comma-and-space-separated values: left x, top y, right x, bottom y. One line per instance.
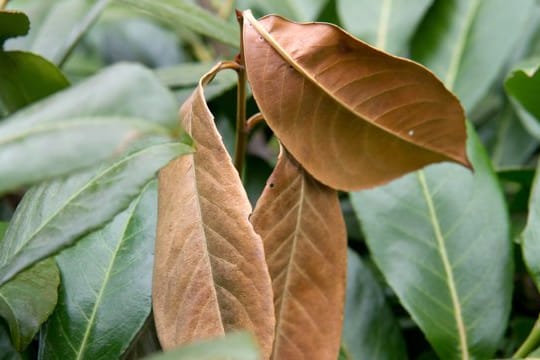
153, 62, 275, 356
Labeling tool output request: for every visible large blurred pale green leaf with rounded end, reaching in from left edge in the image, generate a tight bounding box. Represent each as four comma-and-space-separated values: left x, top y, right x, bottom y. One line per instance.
0, 65, 177, 193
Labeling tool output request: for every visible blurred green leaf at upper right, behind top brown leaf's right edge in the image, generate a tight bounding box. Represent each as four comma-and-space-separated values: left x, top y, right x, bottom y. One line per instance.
412, 0, 535, 112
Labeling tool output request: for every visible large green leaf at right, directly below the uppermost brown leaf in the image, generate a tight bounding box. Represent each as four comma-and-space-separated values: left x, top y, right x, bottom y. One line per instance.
351, 126, 513, 359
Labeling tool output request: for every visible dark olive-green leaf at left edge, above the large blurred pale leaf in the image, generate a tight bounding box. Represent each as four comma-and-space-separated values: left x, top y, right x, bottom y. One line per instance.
0, 51, 69, 112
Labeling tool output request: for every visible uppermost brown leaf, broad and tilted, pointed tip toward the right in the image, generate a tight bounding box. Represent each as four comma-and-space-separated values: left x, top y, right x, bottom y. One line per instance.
243, 11, 470, 190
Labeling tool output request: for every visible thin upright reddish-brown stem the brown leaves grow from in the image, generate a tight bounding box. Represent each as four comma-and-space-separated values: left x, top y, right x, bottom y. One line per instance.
234, 12, 247, 176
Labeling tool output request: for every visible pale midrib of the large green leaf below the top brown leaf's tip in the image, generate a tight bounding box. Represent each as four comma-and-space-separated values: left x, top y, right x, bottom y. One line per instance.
417, 171, 469, 360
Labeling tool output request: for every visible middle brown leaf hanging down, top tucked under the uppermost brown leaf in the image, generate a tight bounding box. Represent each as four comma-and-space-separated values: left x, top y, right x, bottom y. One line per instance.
251, 151, 347, 360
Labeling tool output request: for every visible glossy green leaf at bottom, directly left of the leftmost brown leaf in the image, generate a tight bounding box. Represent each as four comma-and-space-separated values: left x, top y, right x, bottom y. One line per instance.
40, 181, 157, 359
